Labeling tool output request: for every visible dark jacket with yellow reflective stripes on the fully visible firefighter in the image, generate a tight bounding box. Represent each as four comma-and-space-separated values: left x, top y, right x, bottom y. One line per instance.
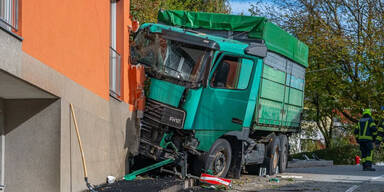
354, 115, 377, 142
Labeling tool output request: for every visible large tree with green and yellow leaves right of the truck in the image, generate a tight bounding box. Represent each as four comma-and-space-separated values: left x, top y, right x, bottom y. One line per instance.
250, 0, 384, 147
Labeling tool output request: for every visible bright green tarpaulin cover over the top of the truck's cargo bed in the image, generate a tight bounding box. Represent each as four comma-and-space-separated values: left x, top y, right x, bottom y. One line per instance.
158, 10, 308, 67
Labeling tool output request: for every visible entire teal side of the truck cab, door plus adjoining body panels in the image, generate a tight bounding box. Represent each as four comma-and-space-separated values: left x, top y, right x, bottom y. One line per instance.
193, 52, 261, 151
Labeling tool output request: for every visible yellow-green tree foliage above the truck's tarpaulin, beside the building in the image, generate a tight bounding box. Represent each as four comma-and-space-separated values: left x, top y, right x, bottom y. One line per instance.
131, 0, 230, 23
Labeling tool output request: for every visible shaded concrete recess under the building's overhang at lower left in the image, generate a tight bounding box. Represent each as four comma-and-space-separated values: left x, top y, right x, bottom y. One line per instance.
4, 99, 60, 192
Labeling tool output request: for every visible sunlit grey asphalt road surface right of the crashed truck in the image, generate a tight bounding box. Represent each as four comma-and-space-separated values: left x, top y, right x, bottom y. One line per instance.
231, 165, 384, 192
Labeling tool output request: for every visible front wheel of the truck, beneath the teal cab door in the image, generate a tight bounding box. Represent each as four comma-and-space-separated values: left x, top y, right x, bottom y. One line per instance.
205, 139, 232, 177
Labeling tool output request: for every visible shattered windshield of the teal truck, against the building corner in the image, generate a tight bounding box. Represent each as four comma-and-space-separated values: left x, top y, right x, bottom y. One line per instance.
131, 30, 211, 82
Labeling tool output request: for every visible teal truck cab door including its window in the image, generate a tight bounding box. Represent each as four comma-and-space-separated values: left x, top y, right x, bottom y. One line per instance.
195, 54, 256, 132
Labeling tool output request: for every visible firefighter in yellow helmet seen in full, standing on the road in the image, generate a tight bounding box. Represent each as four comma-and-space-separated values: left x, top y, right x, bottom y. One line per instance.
354, 109, 377, 171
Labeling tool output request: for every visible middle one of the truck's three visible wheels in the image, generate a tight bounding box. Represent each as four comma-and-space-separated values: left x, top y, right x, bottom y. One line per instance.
265, 136, 280, 175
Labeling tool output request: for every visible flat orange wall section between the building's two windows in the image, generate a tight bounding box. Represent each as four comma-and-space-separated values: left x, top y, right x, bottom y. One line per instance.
21, 0, 110, 99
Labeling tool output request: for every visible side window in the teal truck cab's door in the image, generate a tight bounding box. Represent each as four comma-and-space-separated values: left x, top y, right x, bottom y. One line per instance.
211, 56, 253, 89
